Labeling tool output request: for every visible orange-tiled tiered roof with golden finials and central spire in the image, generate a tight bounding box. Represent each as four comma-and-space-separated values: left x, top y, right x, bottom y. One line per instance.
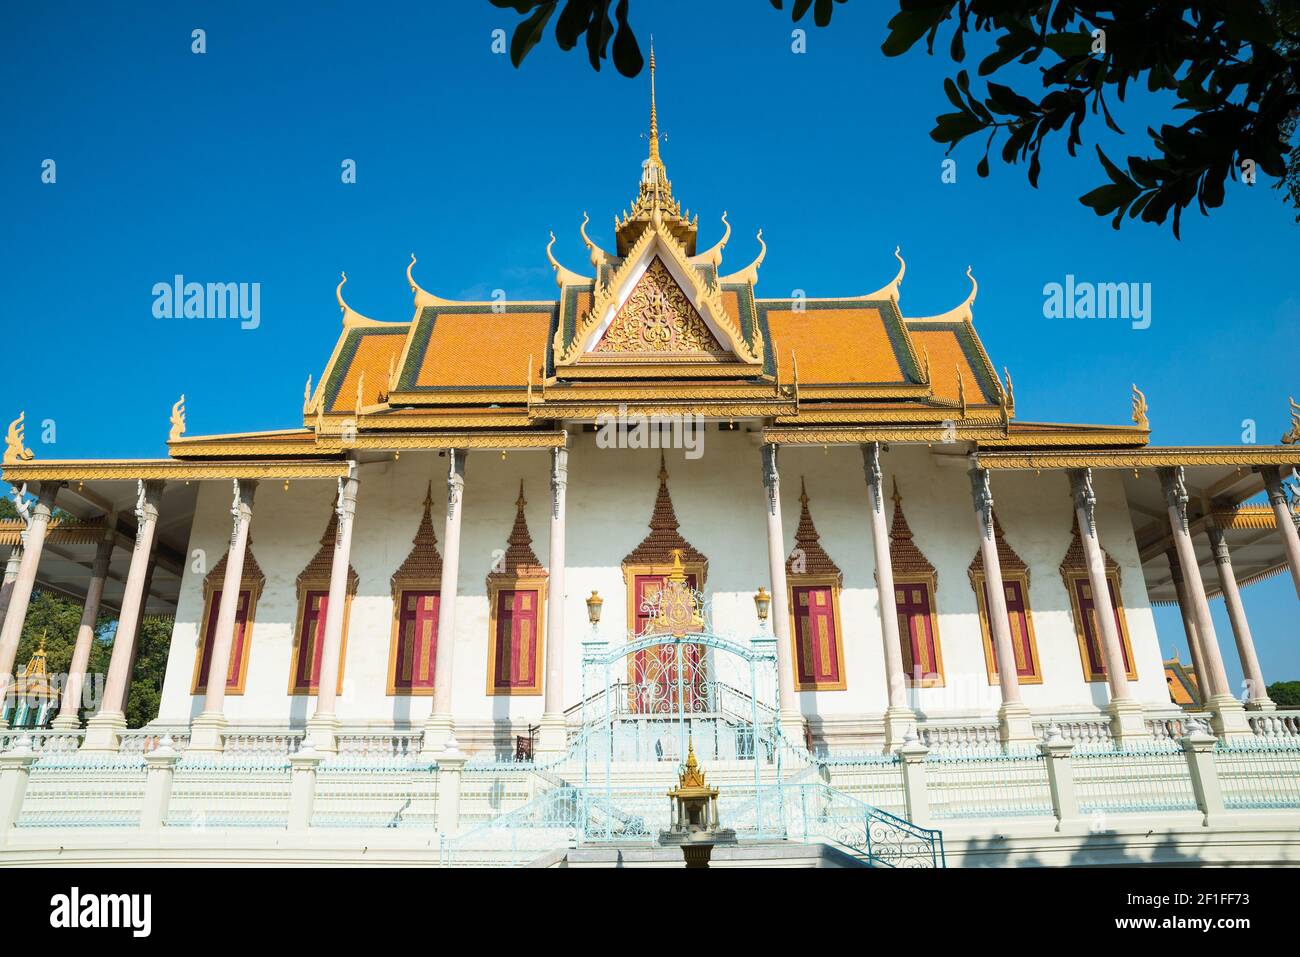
152, 45, 1149, 458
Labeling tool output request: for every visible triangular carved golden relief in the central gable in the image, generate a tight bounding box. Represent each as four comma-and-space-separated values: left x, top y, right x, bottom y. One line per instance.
594, 256, 731, 356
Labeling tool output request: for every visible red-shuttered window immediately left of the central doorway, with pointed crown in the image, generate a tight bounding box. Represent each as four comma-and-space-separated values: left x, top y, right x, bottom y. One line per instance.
488, 482, 547, 694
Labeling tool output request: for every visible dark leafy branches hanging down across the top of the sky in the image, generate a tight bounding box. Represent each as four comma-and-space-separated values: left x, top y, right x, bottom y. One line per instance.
491, 0, 1300, 235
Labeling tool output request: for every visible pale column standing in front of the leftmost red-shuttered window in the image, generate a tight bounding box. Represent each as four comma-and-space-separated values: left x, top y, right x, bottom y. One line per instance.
189, 479, 256, 754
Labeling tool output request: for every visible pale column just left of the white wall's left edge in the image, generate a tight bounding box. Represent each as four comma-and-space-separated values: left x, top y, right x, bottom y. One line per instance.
82, 481, 163, 752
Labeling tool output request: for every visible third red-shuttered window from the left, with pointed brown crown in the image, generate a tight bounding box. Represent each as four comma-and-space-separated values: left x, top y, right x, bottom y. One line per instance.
389, 482, 442, 694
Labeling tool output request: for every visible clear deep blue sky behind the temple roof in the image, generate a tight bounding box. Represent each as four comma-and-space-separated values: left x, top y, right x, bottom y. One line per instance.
0, 0, 1300, 680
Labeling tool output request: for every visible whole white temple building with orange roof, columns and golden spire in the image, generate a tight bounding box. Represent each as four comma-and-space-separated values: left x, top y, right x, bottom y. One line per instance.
0, 56, 1300, 761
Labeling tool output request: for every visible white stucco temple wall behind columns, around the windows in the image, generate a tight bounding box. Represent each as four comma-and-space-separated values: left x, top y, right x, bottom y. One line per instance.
160, 429, 1169, 724
